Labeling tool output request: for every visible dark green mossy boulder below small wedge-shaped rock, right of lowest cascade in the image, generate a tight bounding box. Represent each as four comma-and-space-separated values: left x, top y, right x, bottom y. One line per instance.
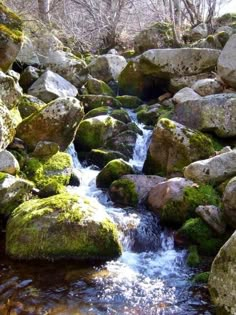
177, 218, 226, 256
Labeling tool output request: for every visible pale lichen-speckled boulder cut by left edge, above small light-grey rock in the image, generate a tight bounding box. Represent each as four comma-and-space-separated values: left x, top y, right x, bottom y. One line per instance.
0, 101, 16, 149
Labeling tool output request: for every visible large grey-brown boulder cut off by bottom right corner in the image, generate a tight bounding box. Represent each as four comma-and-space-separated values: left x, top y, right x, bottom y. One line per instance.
208, 232, 236, 315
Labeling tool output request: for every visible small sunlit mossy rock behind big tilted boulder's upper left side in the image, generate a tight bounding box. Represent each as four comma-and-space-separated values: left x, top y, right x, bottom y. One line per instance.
16, 94, 46, 119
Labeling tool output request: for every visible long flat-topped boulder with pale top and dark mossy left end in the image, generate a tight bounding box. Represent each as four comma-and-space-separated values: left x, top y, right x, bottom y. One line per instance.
119, 48, 220, 99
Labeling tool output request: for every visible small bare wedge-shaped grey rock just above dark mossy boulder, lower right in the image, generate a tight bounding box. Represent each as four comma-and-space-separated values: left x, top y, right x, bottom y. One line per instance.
195, 205, 226, 234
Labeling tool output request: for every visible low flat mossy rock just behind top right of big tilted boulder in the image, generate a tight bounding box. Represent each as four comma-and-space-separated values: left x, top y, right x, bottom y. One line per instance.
78, 95, 122, 113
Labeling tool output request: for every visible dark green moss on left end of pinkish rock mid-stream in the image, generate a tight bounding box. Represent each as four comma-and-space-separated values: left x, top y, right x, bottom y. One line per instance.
109, 178, 138, 207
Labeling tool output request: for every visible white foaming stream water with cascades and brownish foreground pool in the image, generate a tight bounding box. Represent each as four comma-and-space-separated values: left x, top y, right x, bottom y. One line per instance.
0, 116, 214, 315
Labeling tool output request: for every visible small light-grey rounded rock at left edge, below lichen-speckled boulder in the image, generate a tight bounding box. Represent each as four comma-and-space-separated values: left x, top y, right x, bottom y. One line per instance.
0, 150, 20, 175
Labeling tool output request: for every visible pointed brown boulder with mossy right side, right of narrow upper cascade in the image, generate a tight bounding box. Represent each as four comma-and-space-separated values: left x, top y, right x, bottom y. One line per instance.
143, 118, 214, 176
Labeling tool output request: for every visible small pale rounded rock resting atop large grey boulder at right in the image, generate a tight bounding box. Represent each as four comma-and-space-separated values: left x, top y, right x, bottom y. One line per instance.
192, 79, 224, 96
